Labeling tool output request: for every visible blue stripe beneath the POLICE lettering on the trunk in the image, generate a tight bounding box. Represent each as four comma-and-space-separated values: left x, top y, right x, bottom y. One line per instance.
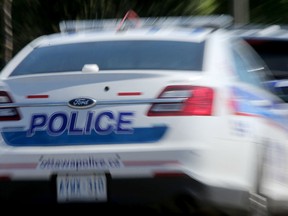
2, 126, 167, 147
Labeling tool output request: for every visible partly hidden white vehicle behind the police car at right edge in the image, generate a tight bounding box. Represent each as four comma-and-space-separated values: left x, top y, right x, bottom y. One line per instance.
231, 24, 288, 102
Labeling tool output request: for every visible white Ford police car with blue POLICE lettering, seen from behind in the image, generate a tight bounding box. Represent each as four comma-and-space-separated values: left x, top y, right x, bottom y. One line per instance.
0, 16, 288, 214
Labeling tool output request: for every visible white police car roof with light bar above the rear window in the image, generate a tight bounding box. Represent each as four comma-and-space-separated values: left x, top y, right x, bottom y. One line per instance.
32, 15, 232, 46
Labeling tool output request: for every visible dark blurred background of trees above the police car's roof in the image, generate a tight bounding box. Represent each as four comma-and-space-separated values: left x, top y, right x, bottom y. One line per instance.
0, 0, 288, 69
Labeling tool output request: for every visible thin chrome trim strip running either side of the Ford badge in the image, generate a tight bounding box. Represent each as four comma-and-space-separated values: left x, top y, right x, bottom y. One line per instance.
0, 98, 186, 108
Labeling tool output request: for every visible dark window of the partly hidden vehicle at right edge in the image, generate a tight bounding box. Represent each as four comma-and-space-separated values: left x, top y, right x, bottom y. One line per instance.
247, 39, 288, 79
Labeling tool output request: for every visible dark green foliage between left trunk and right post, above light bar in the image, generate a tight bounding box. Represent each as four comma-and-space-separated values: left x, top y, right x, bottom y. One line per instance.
12, 0, 225, 53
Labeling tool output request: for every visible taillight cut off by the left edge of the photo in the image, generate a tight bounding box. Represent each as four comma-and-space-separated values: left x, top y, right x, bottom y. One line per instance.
0, 91, 20, 121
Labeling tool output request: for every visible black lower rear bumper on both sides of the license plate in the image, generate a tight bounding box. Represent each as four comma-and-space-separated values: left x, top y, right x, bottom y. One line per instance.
0, 175, 249, 211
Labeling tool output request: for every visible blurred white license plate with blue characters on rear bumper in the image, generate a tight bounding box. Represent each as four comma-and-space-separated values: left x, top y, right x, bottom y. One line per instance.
56, 174, 107, 202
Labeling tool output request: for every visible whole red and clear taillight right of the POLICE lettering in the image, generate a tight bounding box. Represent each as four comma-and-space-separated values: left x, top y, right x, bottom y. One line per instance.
147, 86, 214, 116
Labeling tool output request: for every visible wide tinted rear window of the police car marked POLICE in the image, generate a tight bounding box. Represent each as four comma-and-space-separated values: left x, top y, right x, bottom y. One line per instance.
11, 40, 204, 76
